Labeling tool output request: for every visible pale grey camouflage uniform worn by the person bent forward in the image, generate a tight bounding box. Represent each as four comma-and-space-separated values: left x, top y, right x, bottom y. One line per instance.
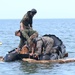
35, 36, 54, 59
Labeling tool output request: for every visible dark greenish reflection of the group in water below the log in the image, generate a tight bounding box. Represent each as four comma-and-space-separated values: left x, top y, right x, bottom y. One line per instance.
19, 62, 57, 74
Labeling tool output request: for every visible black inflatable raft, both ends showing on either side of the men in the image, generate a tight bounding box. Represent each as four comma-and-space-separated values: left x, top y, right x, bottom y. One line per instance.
4, 34, 66, 62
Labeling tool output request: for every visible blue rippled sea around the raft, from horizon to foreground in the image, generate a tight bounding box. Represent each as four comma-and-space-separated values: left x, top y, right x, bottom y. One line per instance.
0, 19, 75, 75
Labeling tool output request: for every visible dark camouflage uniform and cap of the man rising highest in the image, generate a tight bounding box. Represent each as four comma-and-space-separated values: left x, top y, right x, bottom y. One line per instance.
20, 9, 38, 46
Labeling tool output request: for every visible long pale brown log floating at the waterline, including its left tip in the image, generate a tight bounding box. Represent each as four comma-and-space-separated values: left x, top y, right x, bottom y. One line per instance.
0, 57, 75, 64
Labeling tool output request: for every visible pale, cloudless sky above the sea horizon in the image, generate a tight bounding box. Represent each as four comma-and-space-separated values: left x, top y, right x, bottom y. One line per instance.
0, 0, 75, 19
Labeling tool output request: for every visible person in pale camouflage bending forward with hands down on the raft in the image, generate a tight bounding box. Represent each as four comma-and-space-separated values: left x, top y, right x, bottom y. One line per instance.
30, 36, 56, 60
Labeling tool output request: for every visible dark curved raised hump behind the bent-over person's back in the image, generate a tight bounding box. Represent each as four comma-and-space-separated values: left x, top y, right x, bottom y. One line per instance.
43, 34, 65, 56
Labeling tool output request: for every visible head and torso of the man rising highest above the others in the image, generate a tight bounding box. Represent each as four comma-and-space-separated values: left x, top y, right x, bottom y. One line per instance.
20, 9, 37, 30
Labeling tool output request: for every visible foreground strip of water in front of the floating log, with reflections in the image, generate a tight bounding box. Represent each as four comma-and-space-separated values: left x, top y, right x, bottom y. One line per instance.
0, 61, 75, 75
